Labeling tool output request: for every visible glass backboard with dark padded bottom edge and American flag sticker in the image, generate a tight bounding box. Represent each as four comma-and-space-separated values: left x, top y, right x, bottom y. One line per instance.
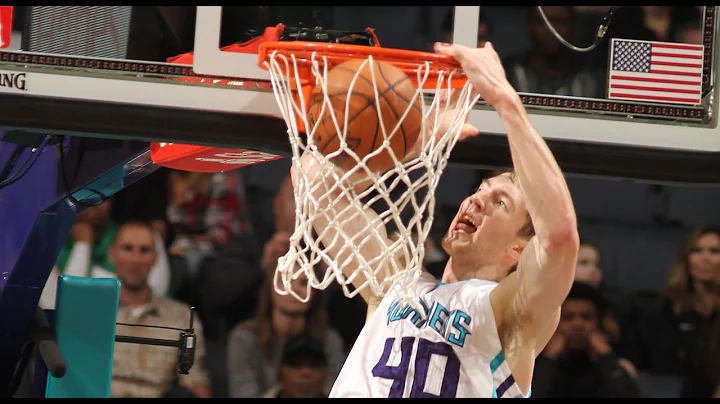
0, 6, 720, 183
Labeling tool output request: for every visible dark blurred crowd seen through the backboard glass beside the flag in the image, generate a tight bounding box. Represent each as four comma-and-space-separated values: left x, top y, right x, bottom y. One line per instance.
434, 6, 705, 98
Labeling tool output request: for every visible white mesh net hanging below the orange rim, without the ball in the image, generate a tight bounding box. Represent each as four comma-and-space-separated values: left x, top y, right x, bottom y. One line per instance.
267, 51, 478, 314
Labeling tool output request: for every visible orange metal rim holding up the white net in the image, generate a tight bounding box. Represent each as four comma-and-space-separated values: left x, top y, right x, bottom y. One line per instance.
258, 41, 467, 89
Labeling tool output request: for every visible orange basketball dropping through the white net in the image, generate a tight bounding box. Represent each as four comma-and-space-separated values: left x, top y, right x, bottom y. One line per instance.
307, 59, 423, 172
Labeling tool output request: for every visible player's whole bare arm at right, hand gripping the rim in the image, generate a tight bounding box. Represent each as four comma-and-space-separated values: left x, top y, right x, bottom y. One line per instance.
436, 43, 578, 330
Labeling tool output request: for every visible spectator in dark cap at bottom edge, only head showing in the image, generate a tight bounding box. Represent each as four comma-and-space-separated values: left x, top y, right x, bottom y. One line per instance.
263, 335, 328, 398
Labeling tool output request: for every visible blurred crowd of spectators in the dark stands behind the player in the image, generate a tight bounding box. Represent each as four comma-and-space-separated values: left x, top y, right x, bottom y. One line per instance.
35, 6, 720, 398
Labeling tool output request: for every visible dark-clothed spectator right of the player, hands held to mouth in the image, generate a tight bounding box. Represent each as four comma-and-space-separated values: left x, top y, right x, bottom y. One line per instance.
532, 282, 639, 398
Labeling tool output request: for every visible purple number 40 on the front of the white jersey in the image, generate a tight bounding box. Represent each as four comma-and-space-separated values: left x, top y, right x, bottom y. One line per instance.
372, 337, 460, 398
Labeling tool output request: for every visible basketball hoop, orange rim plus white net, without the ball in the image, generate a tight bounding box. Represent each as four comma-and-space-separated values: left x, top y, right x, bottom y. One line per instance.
258, 41, 479, 313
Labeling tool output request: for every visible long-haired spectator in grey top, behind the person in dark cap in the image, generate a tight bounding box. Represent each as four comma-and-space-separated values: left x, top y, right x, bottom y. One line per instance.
227, 267, 347, 398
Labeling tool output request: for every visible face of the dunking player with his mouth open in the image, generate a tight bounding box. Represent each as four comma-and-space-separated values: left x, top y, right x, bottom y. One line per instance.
443, 174, 528, 266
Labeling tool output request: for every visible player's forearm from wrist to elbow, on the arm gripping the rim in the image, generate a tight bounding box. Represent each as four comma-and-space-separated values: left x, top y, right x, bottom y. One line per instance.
495, 92, 577, 247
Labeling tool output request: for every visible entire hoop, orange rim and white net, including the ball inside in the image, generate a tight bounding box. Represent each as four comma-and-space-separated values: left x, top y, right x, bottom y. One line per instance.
258, 41, 479, 313
